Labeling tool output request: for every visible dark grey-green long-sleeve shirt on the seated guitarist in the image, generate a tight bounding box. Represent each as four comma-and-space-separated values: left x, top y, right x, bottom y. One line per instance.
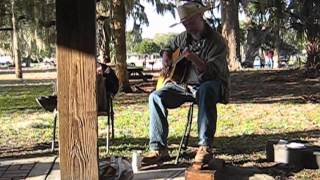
163, 24, 230, 103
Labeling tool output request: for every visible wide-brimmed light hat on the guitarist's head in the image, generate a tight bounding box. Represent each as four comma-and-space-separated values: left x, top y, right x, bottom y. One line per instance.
170, 0, 211, 27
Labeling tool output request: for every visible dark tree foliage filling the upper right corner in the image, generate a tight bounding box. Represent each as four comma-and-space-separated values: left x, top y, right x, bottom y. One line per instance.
244, 0, 320, 73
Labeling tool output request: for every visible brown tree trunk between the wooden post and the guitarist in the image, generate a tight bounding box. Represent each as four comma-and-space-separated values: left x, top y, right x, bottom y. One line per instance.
112, 0, 132, 92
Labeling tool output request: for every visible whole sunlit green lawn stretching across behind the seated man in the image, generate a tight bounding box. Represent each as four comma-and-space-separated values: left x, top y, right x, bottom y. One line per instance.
0, 68, 320, 179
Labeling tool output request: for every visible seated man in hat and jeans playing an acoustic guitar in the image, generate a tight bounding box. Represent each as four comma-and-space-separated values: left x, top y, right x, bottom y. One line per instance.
142, 1, 229, 164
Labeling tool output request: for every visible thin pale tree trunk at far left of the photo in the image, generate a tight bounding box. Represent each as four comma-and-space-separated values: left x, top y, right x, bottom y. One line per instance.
11, 0, 22, 79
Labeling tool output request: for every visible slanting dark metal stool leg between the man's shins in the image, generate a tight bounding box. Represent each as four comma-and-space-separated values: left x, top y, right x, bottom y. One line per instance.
174, 103, 194, 164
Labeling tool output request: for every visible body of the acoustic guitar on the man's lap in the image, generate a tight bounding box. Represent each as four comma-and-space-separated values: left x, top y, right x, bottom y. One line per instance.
156, 48, 191, 90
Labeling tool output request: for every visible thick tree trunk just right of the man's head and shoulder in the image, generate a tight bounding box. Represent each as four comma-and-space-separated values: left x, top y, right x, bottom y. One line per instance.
221, 0, 241, 70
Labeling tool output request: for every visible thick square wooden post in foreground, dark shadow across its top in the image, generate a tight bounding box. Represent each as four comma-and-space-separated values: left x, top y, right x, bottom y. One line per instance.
56, 0, 99, 180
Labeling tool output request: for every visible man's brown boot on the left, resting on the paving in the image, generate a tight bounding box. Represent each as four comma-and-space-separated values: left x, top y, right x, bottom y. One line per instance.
141, 149, 170, 165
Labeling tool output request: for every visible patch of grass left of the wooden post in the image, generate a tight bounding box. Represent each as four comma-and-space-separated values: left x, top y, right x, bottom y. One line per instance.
0, 86, 52, 150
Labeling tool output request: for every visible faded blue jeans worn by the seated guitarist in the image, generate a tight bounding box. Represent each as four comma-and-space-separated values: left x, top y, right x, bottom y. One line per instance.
149, 80, 221, 150
